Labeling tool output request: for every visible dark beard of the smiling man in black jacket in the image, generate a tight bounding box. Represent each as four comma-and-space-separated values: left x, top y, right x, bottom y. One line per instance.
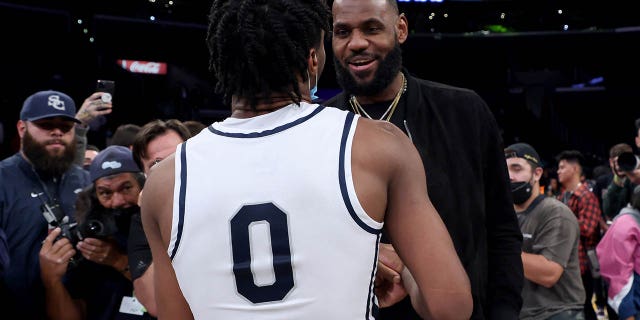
333, 41, 402, 96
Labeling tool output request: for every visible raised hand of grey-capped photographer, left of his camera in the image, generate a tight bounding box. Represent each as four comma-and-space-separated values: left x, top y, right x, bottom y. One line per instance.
39, 228, 76, 286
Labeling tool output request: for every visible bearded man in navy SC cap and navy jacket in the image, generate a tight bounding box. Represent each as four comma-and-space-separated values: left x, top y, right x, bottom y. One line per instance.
0, 91, 91, 319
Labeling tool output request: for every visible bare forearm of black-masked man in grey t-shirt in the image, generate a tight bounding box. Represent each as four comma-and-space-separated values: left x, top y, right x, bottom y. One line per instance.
522, 252, 564, 288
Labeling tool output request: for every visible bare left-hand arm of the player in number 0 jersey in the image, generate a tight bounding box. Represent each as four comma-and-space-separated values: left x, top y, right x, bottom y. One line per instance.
141, 156, 193, 319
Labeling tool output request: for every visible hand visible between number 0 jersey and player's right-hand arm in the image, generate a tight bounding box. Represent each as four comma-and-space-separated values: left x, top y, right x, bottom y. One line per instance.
374, 243, 407, 308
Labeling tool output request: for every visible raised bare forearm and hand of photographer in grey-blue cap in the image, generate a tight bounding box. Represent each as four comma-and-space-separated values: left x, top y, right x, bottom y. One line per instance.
40, 228, 85, 320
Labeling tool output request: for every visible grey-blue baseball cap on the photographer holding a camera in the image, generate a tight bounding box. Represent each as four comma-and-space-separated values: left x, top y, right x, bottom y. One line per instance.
89, 145, 142, 182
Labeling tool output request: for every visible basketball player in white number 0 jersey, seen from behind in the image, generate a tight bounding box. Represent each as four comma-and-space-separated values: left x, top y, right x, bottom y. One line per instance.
142, 0, 472, 320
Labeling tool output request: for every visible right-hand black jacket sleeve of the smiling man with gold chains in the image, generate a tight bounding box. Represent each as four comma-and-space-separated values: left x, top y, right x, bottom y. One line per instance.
478, 96, 524, 320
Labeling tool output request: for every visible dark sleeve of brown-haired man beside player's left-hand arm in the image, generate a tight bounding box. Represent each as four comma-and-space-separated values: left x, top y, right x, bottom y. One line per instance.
127, 213, 152, 280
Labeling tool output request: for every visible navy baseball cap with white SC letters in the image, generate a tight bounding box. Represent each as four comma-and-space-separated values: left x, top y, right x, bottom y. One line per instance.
20, 90, 80, 123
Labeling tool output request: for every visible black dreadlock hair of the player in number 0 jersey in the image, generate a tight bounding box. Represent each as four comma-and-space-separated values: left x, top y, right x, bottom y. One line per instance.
207, 0, 331, 110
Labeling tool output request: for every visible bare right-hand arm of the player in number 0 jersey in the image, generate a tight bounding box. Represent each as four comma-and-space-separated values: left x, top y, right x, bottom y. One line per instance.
362, 120, 473, 319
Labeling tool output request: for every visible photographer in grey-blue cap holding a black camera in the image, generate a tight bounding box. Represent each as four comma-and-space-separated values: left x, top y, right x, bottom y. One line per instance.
40, 146, 147, 320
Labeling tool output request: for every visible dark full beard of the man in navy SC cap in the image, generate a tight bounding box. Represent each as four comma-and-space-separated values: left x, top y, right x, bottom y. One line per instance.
22, 130, 76, 177
